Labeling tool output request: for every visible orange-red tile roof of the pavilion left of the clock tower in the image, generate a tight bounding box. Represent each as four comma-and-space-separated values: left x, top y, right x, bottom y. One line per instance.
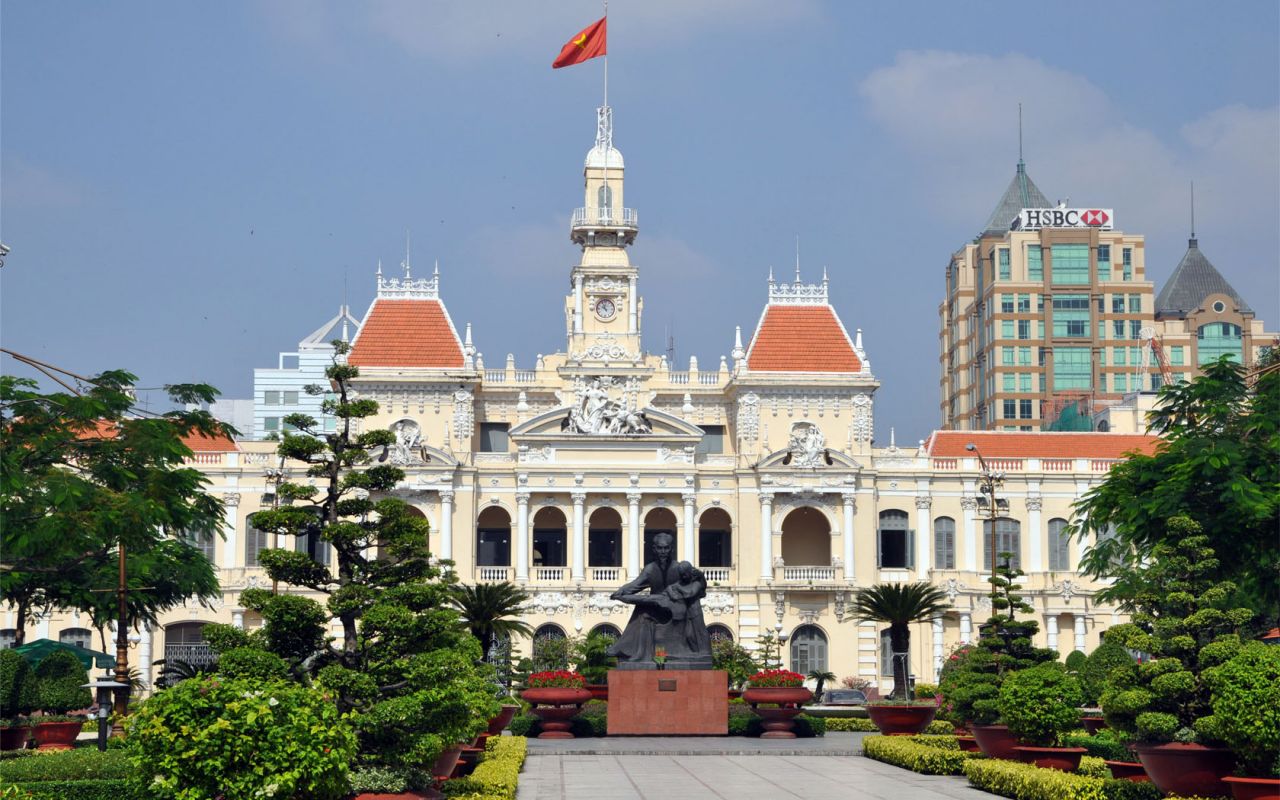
347, 300, 462, 369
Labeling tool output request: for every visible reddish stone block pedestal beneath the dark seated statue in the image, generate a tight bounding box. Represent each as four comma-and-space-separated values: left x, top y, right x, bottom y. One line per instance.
609, 669, 728, 736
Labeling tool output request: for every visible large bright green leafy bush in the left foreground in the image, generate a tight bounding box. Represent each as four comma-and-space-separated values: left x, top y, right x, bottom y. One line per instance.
127, 676, 356, 800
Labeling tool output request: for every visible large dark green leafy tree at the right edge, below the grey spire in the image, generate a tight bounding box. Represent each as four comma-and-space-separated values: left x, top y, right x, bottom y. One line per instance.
1073, 351, 1280, 627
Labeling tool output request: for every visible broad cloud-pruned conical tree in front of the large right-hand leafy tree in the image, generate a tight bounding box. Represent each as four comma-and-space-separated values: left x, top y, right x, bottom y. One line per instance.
1102, 516, 1253, 744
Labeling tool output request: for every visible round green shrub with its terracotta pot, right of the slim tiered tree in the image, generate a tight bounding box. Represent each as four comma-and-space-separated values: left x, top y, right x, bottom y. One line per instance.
1000, 662, 1087, 772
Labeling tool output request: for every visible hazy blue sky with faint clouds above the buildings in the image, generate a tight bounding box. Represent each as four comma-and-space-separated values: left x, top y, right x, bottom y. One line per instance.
0, 0, 1280, 445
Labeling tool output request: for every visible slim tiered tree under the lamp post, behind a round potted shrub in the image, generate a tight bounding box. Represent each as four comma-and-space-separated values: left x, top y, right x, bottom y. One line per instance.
941, 553, 1057, 724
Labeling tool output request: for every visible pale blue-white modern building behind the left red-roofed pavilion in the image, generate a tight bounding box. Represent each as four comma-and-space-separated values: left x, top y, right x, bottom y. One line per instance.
252, 306, 360, 439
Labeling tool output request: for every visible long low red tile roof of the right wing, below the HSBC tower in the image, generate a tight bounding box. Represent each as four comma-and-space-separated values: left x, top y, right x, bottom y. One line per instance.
924, 430, 1160, 458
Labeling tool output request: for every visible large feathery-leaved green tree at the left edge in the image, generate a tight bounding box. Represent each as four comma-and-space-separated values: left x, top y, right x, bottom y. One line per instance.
0, 371, 227, 644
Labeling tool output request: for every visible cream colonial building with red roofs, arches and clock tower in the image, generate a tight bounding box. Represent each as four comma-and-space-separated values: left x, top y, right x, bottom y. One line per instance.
6, 109, 1153, 685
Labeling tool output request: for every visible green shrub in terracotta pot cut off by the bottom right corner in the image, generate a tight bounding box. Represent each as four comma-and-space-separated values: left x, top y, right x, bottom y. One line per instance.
1204, 641, 1280, 800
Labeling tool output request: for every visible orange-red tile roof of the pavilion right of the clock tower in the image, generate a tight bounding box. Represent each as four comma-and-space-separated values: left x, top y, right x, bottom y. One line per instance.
746, 305, 863, 372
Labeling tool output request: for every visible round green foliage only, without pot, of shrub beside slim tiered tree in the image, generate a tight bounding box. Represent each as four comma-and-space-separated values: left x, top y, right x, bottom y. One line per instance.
1000, 662, 1082, 748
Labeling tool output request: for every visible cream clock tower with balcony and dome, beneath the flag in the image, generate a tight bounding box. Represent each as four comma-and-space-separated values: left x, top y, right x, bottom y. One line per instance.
564, 106, 643, 366
